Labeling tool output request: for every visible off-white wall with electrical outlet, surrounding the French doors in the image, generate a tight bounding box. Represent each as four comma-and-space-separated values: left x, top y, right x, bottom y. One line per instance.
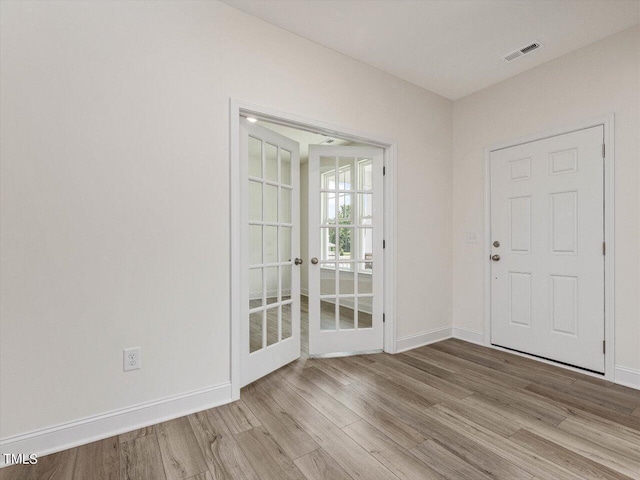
0, 1, 452, 437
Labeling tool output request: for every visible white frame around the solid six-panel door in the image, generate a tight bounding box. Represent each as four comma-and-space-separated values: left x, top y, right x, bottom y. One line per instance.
483, 113, 615, 382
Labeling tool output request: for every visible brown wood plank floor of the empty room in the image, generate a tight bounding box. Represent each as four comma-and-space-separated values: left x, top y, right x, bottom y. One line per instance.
0, 340, 640, 480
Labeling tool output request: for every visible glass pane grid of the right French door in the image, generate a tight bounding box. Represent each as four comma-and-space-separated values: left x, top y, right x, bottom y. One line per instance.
319, 156, 375, 331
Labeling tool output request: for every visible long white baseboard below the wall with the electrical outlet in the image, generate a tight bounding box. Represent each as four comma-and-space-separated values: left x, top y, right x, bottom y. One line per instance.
0, 383, 232, 467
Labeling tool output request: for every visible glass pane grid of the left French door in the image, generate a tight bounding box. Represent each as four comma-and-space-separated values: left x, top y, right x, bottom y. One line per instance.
248, 135, 294, 354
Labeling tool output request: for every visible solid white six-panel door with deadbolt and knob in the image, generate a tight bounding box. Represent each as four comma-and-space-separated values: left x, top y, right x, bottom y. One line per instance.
490, 126, 605, 373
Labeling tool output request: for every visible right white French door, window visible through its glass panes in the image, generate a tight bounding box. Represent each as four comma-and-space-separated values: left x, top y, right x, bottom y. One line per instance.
305, 145, 384, 355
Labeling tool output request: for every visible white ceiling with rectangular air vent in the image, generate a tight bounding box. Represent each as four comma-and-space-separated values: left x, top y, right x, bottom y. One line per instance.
224, 0, 640, 100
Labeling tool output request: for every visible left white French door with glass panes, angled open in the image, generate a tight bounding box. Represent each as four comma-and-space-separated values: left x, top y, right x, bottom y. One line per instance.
240, 119, 300, 386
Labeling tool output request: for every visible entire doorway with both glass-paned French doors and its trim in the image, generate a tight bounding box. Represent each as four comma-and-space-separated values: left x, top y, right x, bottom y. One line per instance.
230, 101, 395, 397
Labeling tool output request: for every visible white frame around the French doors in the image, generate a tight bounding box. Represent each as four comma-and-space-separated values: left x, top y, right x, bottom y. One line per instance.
229, 98, 398, 400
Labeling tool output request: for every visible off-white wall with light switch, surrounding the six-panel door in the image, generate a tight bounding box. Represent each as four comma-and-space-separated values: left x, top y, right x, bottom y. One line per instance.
453, 27, 640, 370
